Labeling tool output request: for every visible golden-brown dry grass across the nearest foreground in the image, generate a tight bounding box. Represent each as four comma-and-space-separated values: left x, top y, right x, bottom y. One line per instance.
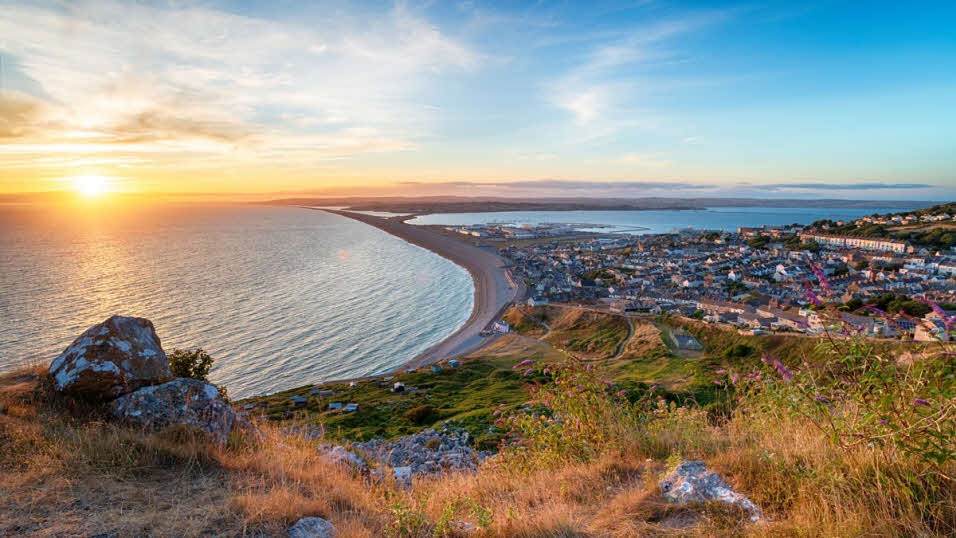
0, 364, 956, 537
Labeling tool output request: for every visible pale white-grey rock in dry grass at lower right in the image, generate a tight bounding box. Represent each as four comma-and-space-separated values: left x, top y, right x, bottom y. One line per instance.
658, 461, 761, 521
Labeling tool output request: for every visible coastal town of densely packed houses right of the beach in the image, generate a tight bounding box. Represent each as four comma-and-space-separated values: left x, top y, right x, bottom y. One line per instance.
460, 204, 956, 341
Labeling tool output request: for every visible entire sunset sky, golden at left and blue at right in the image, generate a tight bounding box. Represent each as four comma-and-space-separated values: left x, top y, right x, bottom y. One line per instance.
0, 0, 956, 200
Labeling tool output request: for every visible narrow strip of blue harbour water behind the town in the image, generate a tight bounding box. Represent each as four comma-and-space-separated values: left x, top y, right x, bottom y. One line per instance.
408, 205, 925, 234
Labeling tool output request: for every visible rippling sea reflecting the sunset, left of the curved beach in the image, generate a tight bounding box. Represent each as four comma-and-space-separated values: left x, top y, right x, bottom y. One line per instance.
0, 206, 473, 397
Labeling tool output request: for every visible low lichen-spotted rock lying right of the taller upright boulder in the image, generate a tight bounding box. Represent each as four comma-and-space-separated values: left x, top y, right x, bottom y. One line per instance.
110, 378, 242, 443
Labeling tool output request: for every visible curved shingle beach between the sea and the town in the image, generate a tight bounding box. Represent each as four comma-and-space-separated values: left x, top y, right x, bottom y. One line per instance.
310, 208, 524, 368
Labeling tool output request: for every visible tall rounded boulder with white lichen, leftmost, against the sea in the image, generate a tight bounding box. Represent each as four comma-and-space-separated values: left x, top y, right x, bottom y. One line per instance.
50, 316, 173, 399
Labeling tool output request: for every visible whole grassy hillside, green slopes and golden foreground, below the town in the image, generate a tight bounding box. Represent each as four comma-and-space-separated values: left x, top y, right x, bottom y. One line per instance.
0, 307, 956, 537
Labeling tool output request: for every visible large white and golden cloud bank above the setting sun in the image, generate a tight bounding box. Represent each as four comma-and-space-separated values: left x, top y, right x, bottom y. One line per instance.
0, 0, 482, 175
